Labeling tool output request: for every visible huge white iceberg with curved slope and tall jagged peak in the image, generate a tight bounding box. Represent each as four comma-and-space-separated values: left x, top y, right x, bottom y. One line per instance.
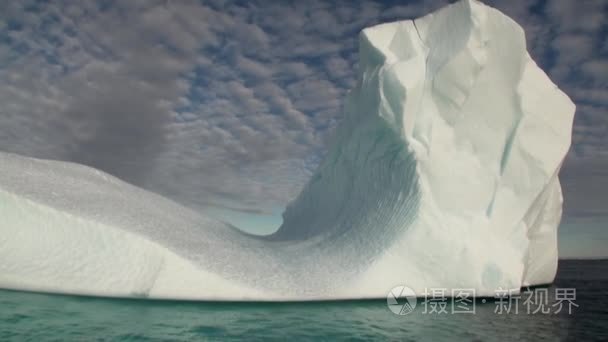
0, 0, 575, 300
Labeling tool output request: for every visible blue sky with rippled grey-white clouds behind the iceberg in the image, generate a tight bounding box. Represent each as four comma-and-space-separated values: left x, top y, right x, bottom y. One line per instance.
0, 0, 608, 255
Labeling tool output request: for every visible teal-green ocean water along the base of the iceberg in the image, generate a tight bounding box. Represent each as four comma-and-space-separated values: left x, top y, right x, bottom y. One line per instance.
0, 260, 608, 341
